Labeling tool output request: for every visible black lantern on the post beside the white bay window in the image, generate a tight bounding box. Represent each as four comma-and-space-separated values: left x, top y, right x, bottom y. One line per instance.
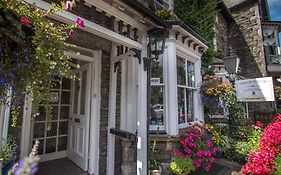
147, 26, 167, 57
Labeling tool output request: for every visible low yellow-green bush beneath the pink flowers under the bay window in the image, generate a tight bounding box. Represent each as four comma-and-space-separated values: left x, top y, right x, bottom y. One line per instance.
170, 157, 195, 175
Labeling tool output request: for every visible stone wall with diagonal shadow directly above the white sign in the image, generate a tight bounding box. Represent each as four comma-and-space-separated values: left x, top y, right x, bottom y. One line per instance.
226, 3, 266, 78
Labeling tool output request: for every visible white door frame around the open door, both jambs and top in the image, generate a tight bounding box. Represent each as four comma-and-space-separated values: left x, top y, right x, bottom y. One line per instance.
20, 46, 102, 174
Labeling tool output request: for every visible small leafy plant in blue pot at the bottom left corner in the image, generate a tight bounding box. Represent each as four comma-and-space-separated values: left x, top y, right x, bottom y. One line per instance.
0, 138, 16, 175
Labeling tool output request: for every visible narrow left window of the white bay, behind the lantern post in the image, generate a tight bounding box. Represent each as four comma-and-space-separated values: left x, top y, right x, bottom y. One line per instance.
150, 57, 165, 130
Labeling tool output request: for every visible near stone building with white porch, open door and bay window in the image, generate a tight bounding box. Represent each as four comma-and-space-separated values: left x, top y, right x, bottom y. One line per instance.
0, 0, 208, 175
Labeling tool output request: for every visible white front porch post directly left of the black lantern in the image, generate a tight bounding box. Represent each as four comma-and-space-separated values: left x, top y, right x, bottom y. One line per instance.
137, 34, 148, 175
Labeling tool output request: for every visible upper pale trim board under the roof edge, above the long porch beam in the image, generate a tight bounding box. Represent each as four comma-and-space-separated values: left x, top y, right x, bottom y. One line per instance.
85, 0, 146, 31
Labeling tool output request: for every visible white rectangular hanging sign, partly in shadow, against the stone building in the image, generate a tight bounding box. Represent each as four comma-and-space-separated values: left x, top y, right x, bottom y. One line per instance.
235, 77, 275, 102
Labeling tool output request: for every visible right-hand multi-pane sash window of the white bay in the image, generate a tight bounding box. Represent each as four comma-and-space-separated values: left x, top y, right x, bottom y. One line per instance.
177, 58, 195, 126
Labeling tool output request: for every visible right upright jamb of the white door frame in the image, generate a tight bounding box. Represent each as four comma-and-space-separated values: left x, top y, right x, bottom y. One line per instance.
88, 50, 102, 174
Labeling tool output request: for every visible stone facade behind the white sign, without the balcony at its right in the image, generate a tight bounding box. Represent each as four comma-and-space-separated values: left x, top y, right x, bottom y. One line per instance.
215, 0, 274, 117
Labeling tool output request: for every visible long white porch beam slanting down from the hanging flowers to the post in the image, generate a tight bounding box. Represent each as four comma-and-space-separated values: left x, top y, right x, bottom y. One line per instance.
25, 0, 143, 50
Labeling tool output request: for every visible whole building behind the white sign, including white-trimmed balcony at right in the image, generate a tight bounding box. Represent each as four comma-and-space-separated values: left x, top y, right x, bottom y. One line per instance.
215, 0, 281, 118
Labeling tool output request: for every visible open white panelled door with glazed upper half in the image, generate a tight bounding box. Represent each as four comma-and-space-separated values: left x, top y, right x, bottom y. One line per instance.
67, 63, 91, 171
